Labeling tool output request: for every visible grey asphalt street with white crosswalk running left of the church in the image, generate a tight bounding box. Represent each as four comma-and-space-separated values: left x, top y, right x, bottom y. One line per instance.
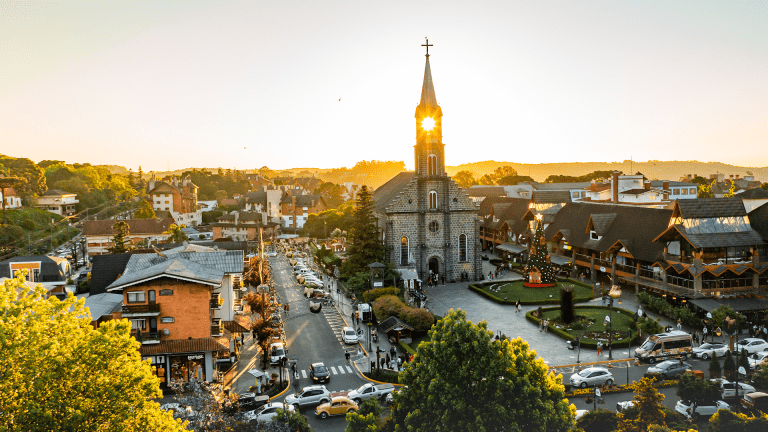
269, 254, 368, 431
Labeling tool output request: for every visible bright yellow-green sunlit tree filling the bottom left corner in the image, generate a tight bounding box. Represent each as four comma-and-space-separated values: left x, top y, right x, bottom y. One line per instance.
0, 274, 184, 431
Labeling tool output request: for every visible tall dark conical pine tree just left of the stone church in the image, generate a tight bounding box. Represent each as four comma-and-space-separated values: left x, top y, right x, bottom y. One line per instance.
341, 186, 384, 278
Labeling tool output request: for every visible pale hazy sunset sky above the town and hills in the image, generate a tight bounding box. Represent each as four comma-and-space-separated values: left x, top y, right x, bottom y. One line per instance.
0, 0, 768, 171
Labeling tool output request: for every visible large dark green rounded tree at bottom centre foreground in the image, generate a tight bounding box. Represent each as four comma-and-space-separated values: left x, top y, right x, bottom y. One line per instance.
392, 309, 576, 432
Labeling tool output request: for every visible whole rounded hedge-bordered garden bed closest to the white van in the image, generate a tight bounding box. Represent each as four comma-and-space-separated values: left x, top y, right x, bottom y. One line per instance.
525, 306, 639, 349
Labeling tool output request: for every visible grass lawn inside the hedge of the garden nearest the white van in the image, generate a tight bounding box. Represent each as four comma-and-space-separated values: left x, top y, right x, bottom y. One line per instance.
542, 306, 637, 345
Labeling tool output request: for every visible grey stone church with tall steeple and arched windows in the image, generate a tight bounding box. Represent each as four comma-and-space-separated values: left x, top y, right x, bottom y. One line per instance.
373, 42, 482, 282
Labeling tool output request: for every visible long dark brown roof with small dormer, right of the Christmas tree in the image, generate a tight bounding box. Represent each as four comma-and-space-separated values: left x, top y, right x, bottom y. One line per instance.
544, 202, 672, 262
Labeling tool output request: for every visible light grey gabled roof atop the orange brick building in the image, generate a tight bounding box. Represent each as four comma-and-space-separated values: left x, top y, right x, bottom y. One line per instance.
107, 252, 224, 291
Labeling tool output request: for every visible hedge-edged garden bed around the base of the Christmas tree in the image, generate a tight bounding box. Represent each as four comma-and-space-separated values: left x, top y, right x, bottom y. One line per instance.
468, 279, 593, 305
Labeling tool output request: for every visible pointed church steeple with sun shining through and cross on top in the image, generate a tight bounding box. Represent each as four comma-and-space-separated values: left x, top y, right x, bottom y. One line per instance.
414, 40, 445, 177
